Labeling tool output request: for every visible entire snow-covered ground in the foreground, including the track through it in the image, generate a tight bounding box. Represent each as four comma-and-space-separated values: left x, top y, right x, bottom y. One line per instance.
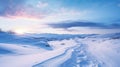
0, 34, 120, 67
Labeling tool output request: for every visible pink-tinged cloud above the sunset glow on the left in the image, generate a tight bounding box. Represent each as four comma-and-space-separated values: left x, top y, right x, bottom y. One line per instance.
6, 7, 45, 19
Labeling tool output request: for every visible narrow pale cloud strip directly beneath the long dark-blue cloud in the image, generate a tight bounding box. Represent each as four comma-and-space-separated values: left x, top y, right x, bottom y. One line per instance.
66, 27, 120, 34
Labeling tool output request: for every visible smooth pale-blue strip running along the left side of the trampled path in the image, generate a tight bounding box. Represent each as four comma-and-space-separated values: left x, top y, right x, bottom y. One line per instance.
33, 47, 74, 67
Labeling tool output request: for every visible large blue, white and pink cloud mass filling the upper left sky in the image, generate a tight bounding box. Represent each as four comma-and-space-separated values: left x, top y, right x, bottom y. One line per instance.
0, 0, 89, 22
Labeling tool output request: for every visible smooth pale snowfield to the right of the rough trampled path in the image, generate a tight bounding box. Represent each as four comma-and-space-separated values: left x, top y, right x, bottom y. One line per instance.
81, 38, 120, 67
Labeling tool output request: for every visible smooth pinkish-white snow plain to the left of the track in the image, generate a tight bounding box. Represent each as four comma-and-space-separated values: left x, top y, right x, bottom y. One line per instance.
0, 39, 76, 67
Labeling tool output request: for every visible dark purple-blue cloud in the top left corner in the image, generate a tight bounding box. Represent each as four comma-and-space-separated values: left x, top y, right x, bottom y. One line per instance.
0, 0, 25, 16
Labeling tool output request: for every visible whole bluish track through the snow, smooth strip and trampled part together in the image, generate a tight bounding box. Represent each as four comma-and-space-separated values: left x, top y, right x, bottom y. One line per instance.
33, 42, 101, 67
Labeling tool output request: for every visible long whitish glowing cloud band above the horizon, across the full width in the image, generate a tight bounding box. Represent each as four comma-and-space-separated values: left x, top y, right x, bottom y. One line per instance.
0, 17, 120, 34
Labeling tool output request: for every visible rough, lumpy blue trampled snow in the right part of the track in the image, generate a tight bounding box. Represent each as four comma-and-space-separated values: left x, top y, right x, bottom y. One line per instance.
60, 41, 101, 67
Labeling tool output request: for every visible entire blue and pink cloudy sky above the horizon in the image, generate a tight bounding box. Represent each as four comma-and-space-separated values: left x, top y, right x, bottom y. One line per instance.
0, 0, 120, 34
